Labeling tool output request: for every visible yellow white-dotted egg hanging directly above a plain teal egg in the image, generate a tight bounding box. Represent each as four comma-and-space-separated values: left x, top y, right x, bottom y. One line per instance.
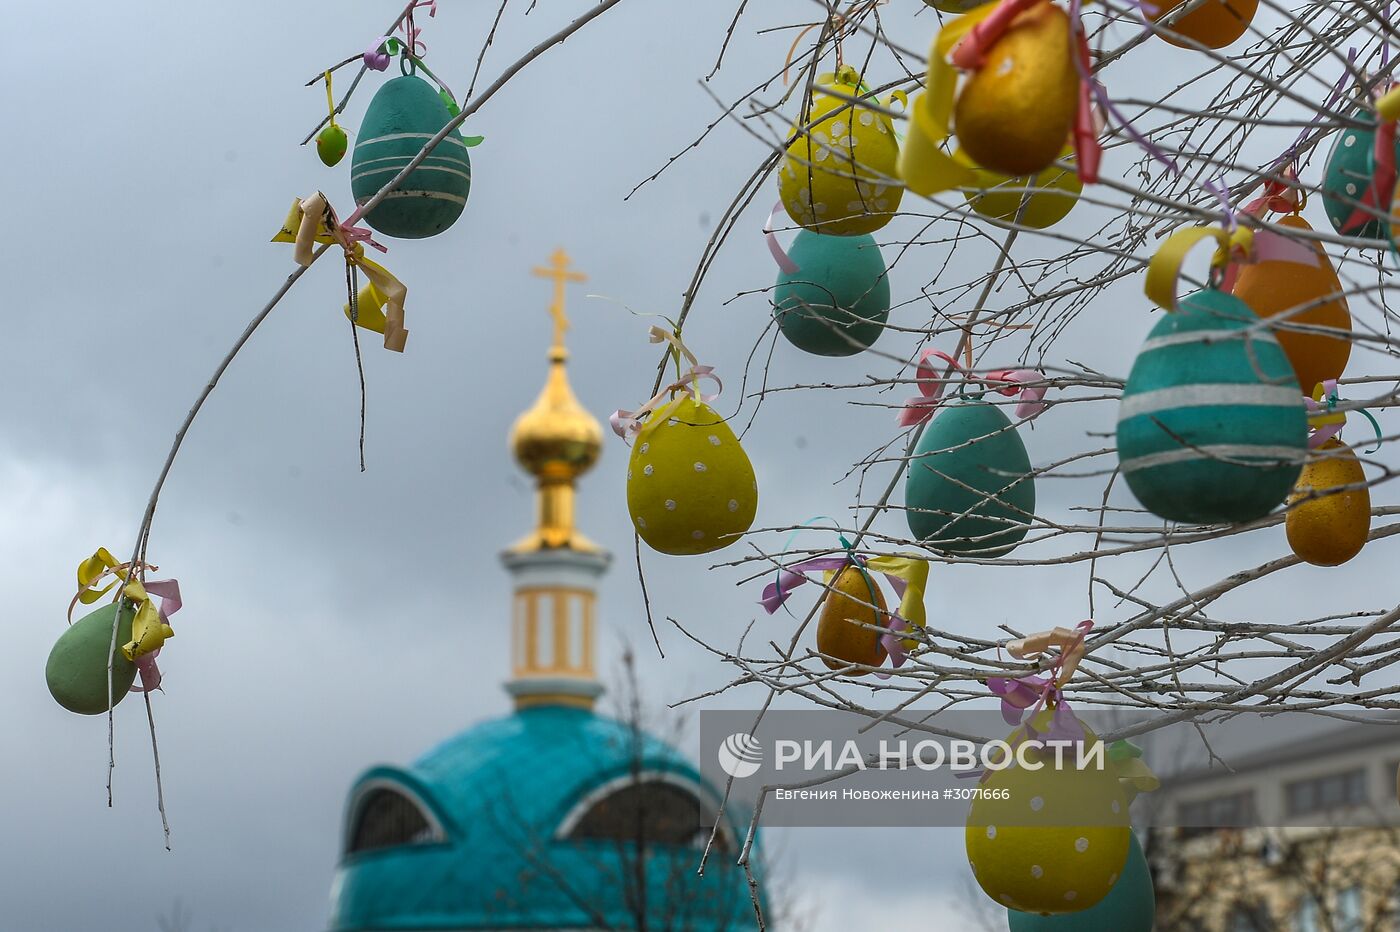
778, 67, 904, 236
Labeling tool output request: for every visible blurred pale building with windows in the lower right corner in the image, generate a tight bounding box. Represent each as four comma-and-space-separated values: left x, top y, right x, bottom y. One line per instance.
1147, 725, 1400, 932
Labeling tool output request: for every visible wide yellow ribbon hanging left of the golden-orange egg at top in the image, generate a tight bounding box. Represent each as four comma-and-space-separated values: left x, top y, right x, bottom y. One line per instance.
897, 3, 997, 197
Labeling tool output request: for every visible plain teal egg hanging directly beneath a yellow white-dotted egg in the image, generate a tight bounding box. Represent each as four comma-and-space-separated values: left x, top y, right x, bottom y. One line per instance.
773, 230, 889, 355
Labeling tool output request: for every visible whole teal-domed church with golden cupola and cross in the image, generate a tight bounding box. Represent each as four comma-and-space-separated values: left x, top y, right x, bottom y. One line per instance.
330, 250, 755, 932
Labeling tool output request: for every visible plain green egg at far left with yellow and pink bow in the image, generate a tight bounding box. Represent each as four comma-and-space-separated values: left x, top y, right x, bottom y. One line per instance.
43, 602, 136, 715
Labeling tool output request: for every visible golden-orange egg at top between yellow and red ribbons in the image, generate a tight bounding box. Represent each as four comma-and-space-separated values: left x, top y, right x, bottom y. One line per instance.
953, 3, 1079, 178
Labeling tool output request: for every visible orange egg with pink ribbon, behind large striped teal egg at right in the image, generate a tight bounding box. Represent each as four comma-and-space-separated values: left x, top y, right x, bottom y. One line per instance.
1235, 214, 1351, 393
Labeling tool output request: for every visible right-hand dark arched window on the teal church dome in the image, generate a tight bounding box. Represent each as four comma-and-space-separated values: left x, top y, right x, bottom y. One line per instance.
559, 774, 732, 851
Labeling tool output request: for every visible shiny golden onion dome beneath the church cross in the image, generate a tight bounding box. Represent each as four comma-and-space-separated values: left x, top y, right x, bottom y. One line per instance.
511, 346, 603, 481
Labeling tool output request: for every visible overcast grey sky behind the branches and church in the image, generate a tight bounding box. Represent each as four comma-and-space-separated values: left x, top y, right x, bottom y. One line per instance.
0, 0, 1383, 932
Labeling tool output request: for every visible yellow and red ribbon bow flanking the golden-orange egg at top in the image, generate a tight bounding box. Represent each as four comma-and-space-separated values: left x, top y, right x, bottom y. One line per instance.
899, 0, 1102, 197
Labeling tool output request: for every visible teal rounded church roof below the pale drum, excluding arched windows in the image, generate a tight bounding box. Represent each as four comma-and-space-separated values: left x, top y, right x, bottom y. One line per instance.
332, 705, 753, 932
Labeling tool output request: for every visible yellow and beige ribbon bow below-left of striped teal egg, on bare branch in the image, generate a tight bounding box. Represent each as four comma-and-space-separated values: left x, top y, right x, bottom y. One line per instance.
272, 190, 409, 353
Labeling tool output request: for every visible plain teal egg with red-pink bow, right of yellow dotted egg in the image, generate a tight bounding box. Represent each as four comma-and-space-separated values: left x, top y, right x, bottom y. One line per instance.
904, 397, 1036, 557
